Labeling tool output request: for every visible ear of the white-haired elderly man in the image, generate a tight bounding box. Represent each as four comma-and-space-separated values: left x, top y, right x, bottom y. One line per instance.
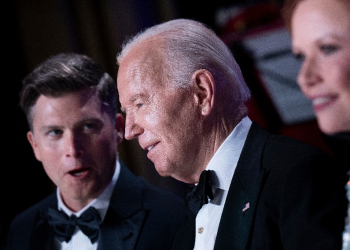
192, 69, 215, 116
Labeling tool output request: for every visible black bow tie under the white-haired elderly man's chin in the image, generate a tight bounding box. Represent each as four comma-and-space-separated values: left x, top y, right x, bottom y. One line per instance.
186, 170, 214, 215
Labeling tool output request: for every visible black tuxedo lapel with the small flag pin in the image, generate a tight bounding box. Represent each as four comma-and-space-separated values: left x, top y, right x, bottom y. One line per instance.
214, 123, 269, 250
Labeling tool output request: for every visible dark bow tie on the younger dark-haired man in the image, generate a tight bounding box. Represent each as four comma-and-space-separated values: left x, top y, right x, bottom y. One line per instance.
47, 207, 101, 244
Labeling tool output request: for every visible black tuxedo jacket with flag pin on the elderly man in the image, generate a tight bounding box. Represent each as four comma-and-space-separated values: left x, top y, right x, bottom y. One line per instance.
173, 123, 347, 250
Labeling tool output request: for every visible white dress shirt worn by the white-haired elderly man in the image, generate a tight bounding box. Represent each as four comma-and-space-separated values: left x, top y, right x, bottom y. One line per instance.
194, 117, 252, 250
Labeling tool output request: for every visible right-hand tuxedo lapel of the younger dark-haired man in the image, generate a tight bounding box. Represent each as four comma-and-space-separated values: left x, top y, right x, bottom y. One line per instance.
98, 163, 146, 250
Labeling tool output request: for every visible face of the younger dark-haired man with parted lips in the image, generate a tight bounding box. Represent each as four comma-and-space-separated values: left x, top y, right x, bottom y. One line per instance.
27, 89, 123, 210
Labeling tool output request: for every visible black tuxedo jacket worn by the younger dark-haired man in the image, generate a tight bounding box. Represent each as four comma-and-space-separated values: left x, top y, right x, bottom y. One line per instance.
8, 164, 185, 250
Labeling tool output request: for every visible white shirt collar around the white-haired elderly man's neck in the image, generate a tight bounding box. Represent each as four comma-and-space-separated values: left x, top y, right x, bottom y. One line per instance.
206, 117, 252, 190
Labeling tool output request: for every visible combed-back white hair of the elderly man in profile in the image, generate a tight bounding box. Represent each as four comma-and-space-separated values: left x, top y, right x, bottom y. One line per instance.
117, 19, 250, 112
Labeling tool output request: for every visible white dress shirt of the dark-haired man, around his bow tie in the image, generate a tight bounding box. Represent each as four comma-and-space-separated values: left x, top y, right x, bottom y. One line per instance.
53, 160, 120, 250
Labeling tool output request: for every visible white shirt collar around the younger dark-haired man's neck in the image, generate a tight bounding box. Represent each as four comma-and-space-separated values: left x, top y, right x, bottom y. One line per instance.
56, 159, 120, 221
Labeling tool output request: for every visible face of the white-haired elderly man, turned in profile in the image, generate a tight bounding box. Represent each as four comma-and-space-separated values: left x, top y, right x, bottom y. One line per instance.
117, 47, 204, 182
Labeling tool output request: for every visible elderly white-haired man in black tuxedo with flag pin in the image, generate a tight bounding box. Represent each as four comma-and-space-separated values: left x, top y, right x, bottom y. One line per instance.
117, 19, 346, 250
